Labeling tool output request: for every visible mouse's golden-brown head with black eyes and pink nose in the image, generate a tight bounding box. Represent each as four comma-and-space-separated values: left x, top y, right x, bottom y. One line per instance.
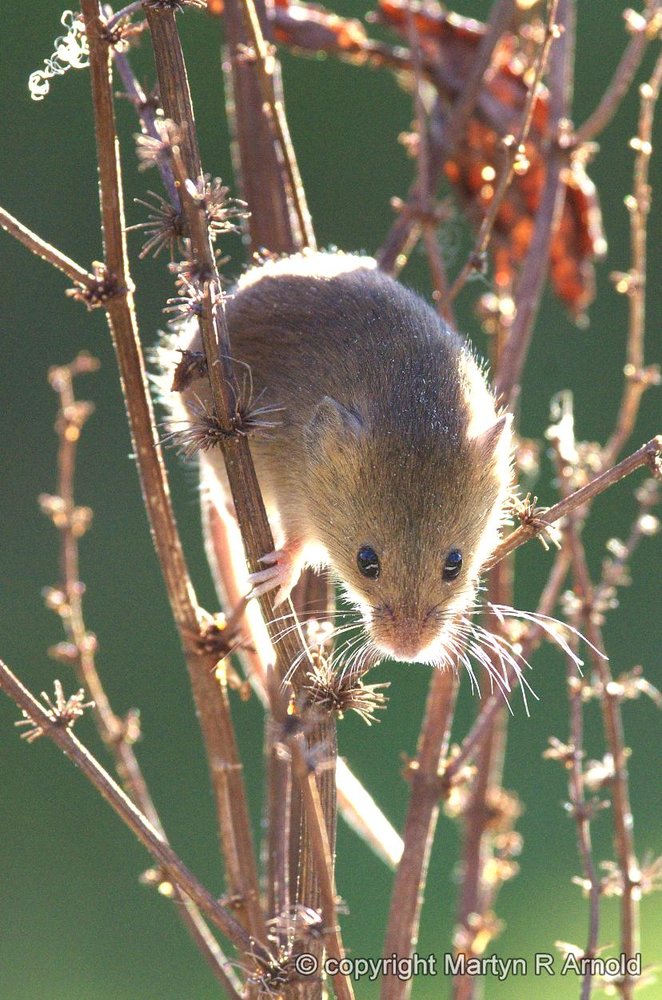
305, 390, 511, 664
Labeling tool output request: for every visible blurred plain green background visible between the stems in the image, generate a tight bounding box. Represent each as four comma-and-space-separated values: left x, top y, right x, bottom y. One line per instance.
0, 0, 662, 1000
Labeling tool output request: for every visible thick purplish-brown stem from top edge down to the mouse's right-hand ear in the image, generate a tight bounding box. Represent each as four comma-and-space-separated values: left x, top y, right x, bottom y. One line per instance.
495, 0, 575, 403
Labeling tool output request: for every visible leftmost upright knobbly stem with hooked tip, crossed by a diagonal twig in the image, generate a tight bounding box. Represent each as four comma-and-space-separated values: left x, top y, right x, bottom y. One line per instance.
44, 355, 240, 995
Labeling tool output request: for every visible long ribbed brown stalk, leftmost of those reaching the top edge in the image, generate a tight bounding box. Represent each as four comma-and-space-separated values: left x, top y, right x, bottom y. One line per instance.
81, 0, 266, 940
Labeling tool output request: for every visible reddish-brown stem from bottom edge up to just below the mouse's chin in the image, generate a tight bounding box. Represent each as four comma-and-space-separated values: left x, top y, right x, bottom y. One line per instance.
380, 670, 458, 1000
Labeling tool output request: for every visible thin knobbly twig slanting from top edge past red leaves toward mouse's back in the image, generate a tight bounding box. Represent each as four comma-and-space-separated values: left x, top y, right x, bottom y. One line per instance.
449, 0, 559, 301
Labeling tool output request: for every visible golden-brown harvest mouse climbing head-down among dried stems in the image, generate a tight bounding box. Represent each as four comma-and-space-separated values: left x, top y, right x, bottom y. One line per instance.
162, 252, 512, 664
